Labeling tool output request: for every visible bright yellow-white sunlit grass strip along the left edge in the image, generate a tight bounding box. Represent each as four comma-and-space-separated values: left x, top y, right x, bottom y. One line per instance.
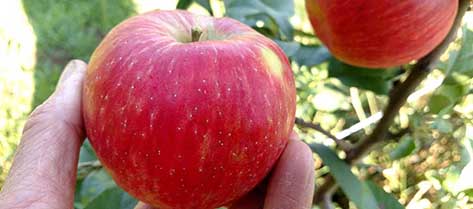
0, 1, 36, 186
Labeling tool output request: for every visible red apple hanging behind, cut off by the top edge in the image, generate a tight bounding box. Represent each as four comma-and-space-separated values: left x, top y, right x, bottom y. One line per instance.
306, 0, 458, 68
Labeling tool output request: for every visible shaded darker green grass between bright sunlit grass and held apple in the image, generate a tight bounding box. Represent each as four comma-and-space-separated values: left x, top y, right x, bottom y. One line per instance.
23, 0, 135, 107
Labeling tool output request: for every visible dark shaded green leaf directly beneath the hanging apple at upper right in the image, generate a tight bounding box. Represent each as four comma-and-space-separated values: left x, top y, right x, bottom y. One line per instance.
328, 58, 400, 95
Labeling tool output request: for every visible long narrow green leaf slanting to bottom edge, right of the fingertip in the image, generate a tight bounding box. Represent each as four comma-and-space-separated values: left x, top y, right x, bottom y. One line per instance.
310, 143, 379, 209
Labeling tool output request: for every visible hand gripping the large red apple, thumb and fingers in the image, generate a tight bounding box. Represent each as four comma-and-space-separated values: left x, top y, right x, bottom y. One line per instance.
0, 60, 314, 209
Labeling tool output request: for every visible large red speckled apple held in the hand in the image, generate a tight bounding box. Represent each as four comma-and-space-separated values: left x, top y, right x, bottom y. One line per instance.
83, 11, 296, 209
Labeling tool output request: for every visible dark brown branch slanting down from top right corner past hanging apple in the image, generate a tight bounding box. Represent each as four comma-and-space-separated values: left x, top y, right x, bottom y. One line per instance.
314, 0, 470, 204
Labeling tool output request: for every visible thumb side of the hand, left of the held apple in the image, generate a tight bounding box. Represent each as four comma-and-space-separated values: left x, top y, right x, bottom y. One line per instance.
0, 60, 87, 209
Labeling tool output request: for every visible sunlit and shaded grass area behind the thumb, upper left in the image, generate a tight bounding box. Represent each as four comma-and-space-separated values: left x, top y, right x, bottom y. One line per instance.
0, 0, 136, 188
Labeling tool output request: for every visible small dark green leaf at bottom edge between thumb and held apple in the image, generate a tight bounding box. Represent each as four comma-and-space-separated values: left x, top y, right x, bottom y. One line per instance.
85, 187, 138, 209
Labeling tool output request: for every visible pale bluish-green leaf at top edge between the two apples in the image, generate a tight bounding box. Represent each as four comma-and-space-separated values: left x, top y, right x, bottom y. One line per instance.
224, 0, 294, 40
